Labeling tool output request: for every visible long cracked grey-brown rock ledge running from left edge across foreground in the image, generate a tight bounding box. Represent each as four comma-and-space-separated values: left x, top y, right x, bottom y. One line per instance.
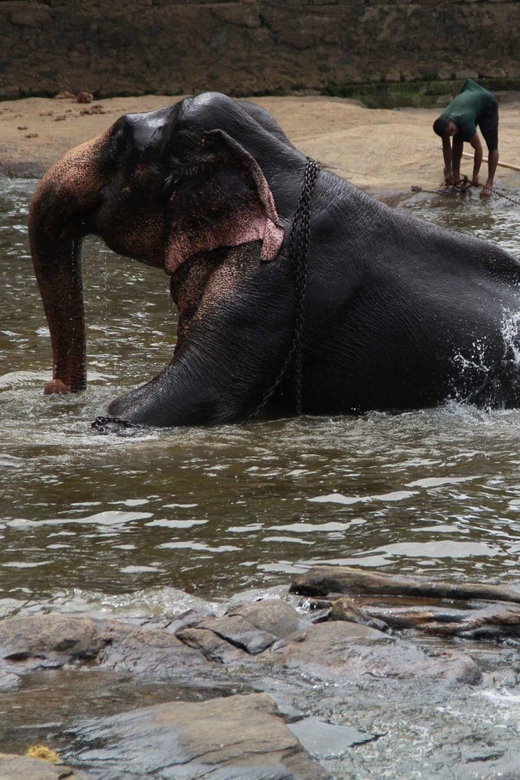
0, 600, 482, 687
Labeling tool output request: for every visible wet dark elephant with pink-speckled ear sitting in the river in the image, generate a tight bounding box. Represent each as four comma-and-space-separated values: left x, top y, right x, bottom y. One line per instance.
29, 92, 520, 427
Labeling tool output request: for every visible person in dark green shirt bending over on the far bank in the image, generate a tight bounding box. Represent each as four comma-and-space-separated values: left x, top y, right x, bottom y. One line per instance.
433, 79, 498, 197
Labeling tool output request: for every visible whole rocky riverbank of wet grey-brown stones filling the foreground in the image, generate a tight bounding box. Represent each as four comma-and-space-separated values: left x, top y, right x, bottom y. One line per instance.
0, 567, 520, 780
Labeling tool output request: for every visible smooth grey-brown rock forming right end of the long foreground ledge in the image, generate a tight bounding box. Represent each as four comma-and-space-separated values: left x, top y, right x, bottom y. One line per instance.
262, 622, 482, 685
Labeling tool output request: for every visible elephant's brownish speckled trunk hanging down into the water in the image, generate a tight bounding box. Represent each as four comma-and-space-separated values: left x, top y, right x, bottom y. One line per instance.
29, 137, 104, 393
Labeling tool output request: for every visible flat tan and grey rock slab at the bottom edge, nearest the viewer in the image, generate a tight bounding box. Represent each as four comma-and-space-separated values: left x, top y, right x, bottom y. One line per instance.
70, 694, 330, 780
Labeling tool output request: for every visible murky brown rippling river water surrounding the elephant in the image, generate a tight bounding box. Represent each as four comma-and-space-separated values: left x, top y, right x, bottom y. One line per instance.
0, 179, 520, 777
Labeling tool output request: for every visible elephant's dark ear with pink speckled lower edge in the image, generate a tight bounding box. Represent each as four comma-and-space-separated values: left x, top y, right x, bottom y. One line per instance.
165, 130, 284, 274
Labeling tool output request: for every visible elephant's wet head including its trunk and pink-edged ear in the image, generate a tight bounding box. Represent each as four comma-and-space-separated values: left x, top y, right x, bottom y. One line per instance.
30, 93, 296, 406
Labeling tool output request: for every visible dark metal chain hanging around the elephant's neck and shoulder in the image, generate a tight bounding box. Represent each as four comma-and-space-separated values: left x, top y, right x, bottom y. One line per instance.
245, 157, 321, 423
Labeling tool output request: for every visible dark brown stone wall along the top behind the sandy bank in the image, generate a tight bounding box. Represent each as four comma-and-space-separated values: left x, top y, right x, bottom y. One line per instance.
0, 0, 520, 98
